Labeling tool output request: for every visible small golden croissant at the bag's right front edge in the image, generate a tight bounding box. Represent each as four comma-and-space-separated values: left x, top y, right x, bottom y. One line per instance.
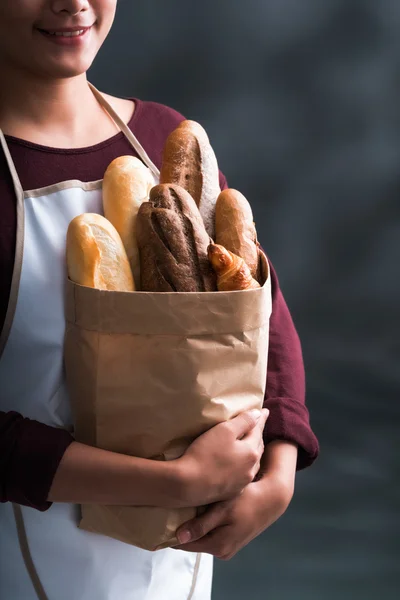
208, 244, 261, 292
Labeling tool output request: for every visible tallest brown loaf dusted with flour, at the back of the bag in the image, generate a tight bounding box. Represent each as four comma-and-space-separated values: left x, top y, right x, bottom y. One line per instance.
160, 121, 221, 239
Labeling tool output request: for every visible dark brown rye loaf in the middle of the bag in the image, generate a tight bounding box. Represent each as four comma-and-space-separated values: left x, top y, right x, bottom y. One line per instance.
136, 184, 217, 292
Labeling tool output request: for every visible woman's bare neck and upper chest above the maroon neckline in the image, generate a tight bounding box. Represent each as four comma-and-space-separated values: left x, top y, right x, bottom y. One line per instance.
0, 63, 115, 148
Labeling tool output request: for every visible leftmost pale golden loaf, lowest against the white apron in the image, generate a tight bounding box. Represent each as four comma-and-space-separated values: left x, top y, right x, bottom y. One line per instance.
67, 213, 135, 292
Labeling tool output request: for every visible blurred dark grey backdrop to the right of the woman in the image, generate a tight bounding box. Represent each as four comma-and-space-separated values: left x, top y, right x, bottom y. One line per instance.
91, 0, 400, 600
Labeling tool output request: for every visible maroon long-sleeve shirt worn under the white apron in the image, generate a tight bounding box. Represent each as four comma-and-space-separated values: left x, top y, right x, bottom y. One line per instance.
0, 99, 318, 510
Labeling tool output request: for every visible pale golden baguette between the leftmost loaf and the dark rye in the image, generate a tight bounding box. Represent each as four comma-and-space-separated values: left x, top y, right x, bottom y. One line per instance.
103, 156, 154, 289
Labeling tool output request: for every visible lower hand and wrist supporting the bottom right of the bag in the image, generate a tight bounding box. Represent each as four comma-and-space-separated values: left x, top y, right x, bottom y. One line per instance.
175, 442, 297, 560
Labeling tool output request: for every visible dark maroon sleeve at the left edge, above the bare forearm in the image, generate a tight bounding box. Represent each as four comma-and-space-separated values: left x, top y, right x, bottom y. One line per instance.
0, 412, 73, 511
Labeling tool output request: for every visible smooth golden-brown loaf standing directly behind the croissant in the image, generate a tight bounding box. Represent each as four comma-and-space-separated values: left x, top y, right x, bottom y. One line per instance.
215, 189, 259, 279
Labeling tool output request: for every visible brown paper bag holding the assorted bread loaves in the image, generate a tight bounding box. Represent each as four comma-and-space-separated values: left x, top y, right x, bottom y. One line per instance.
65, 256, 271, 550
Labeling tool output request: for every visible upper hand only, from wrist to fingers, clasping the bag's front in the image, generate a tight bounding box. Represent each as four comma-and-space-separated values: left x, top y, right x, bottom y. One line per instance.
176, 409, 269, 506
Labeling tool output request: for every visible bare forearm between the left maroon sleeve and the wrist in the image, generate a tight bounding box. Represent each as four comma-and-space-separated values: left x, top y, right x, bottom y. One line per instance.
48, 442, 183, 507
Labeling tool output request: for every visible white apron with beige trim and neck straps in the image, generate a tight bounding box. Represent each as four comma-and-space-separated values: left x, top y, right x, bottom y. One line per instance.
0, 86, 212, 600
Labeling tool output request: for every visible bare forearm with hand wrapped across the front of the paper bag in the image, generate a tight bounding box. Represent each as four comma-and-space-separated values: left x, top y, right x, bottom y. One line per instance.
48, 411, 268, 508
